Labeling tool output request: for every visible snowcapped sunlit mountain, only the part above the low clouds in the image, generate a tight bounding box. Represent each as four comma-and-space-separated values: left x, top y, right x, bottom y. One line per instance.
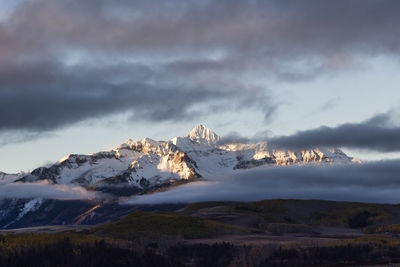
13, 125, 353, 195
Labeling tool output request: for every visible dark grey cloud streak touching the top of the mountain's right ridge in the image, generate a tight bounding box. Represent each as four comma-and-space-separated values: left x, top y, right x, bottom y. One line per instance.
267, 113, 400, 152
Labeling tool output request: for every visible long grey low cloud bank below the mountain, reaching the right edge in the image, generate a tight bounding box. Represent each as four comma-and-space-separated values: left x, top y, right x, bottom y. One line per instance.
121, 160, 400, 204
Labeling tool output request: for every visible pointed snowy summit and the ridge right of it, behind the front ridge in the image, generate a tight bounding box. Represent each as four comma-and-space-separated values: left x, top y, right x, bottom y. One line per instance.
171, 125, 352, 177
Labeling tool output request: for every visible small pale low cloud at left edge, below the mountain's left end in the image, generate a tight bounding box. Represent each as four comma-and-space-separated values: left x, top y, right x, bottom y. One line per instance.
0, 181, 99, 200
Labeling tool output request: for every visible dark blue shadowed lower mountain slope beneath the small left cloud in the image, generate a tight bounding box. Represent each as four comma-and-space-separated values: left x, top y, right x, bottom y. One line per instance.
0, 199, 185, 229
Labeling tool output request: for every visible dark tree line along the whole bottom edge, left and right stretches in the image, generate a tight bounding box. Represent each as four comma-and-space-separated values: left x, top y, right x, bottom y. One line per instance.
0, 237, 400, 267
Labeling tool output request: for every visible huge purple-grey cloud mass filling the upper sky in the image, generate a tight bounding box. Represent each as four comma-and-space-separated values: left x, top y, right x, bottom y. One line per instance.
0, 0, 400, 132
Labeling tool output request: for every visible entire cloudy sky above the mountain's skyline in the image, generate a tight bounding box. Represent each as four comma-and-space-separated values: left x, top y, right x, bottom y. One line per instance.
0, 0, 400, 172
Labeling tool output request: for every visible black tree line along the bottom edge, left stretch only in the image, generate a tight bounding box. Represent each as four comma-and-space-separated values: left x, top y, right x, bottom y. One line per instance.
0, 238, 233, 267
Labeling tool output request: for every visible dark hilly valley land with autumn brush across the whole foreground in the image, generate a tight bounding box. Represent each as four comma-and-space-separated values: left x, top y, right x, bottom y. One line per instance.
0, 200, 400, 267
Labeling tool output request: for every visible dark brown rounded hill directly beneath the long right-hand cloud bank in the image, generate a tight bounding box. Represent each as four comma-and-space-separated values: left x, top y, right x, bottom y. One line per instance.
182, 199, 400, 232
